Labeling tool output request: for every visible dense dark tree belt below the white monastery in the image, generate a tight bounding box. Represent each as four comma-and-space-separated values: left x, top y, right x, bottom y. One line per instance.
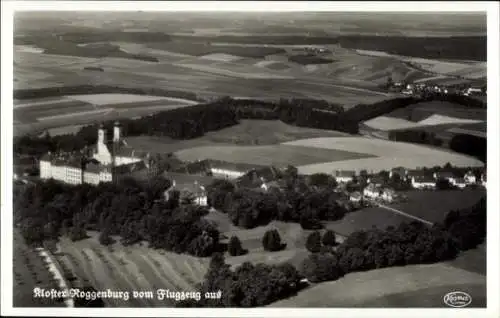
13, 177, 220, 257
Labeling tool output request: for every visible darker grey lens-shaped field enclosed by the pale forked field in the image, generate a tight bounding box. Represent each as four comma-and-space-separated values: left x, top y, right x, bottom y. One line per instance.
175, 143, 370, 167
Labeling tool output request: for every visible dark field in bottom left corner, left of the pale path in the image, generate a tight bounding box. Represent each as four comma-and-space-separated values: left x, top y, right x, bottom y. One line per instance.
13, 231, 64, 307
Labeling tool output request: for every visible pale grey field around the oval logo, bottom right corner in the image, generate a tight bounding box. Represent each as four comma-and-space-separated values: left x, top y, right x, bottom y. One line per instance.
270, 247, 486, 308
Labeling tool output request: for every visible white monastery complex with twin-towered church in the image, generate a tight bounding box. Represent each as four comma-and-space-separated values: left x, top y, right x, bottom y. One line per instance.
40, 123, 161, 184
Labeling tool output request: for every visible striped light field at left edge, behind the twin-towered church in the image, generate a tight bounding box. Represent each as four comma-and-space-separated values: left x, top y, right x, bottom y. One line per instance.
14, 94, 195, 134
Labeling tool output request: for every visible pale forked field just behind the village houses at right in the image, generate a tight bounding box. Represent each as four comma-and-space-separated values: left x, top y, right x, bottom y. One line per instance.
284, 137, 484, 174
